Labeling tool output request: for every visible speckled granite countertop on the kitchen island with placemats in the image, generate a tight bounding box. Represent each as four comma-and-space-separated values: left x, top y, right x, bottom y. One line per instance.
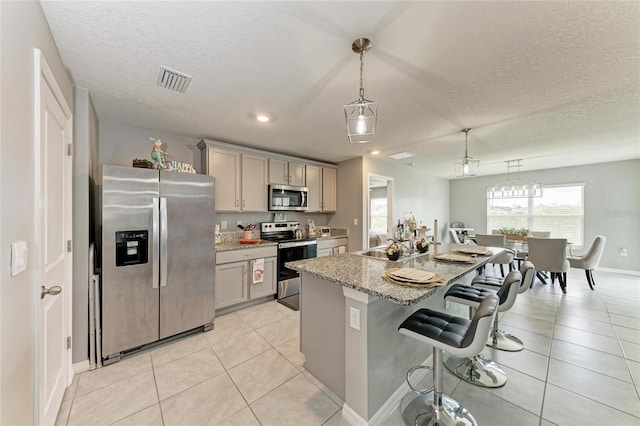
286, 244, 504, 306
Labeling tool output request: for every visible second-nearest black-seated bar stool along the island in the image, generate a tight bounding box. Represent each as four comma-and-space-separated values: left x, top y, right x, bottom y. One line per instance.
444, 271, 522, 388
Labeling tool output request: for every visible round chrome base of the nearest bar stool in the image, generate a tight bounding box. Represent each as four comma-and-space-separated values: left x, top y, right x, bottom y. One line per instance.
400, 392, 478, 426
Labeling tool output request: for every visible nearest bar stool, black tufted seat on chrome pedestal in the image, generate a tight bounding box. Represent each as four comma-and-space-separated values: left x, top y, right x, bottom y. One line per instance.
398, 294, 499, 426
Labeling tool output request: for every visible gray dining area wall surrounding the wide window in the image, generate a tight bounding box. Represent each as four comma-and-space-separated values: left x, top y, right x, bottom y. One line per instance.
450, 160, 640, 271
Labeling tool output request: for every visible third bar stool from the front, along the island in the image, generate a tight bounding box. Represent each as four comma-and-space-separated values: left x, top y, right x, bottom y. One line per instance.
471, 260, 536, 352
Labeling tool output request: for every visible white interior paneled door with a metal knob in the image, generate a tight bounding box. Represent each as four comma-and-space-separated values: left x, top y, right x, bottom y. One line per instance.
34, 50, 72, 425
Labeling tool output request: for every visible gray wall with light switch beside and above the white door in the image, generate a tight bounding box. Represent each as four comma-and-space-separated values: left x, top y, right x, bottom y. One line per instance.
0, 1, 73, 425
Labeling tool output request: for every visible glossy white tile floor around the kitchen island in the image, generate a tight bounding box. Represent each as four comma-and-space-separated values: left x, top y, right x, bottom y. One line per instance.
56, 270, 640, 426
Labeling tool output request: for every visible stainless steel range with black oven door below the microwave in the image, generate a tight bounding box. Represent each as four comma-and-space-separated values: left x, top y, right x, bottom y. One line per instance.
260, 222, 317, 311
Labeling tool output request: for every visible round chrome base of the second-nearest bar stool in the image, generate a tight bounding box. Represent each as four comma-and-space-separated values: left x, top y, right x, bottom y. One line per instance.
444, 354, 507, 388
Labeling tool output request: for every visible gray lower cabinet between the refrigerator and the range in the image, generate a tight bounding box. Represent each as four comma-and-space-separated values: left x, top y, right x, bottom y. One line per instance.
215, 246, 278, 309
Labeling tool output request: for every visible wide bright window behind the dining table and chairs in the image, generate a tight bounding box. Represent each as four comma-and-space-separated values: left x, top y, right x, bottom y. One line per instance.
487, 184, 584, 247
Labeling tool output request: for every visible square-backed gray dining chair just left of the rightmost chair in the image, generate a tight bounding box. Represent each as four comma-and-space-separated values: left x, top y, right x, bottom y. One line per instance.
527, 237, 570, 294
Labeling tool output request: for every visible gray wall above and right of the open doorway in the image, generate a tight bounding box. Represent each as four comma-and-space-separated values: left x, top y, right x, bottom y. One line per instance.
364, 158, 449, 241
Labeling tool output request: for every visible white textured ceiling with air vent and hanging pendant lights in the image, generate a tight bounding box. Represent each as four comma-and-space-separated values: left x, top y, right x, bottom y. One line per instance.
42, 1, 640, 178
